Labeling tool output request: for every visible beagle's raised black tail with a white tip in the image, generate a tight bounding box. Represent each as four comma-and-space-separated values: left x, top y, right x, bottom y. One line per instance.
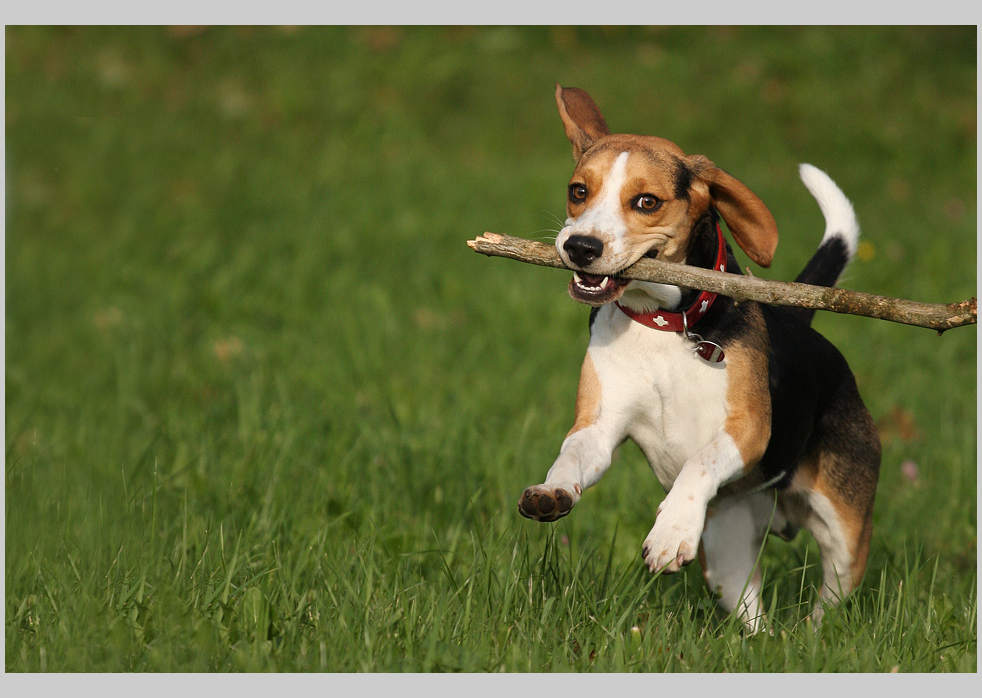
788, 164, 859, 323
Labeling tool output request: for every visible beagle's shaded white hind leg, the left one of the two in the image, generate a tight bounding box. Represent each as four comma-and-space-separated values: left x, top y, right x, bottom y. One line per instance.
699, 492, 787, 633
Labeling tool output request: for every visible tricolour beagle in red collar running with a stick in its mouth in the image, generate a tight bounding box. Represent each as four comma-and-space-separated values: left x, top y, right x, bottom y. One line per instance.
518, 85, 880, 632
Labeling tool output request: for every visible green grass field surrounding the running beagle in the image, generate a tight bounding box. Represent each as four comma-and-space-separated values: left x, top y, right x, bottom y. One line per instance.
4, 27, 978, 672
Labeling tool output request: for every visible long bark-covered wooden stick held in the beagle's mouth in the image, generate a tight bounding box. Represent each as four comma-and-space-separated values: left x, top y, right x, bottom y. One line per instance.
467, 233, 977, 334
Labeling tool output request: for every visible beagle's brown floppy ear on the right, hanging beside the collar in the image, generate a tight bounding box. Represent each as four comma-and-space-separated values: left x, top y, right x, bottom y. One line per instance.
689, 155, 777, 267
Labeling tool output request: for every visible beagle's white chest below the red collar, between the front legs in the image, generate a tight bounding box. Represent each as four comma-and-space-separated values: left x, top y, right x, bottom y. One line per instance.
587, 304, 727, 491
